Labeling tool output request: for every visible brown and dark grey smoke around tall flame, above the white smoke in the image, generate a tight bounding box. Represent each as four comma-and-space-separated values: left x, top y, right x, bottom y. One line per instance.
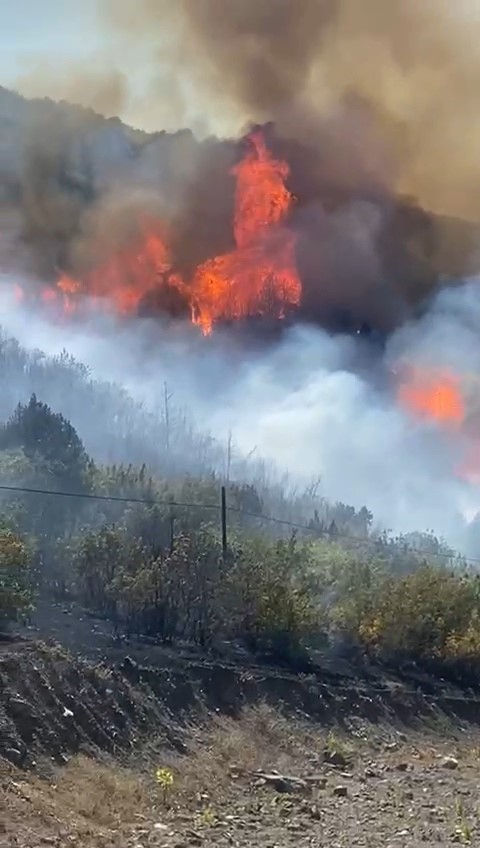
5, 0, 480, 331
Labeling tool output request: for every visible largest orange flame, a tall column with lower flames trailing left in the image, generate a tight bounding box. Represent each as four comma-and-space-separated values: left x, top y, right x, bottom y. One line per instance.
17, 131, 301, 334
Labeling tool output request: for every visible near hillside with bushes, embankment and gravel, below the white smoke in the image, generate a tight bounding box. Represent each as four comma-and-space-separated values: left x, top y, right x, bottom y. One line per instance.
0, 380, 480, 848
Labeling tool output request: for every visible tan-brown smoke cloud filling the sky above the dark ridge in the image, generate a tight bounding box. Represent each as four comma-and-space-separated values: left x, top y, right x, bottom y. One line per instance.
102, 0, 480, 219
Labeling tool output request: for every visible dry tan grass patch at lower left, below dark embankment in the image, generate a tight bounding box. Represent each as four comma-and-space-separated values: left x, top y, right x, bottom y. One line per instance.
0, 705, 336, 848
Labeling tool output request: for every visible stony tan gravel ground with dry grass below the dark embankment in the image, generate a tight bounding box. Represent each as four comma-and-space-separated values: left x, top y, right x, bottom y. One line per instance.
0, 709, 480, 848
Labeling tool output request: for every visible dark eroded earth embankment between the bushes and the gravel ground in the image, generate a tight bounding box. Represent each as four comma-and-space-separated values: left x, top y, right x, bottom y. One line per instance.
0, 641, 480, 767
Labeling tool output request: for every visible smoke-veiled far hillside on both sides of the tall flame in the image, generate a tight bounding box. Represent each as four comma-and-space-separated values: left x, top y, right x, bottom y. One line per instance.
0, 83, 478, 331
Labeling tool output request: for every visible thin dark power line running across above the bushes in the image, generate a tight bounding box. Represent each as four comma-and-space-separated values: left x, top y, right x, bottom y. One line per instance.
0, 484, 480, 563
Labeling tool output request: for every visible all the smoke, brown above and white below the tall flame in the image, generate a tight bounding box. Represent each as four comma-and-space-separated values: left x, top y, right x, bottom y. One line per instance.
4, 0, 480, 546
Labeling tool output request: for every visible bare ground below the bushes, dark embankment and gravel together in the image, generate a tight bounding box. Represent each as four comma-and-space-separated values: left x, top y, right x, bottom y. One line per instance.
0, 605, 480, 848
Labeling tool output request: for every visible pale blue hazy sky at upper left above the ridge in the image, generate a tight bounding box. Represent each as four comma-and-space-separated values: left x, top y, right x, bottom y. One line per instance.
0, 0, 213, 132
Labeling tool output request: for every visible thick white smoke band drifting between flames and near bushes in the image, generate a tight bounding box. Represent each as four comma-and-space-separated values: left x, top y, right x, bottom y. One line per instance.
1, 280, 480, 549
